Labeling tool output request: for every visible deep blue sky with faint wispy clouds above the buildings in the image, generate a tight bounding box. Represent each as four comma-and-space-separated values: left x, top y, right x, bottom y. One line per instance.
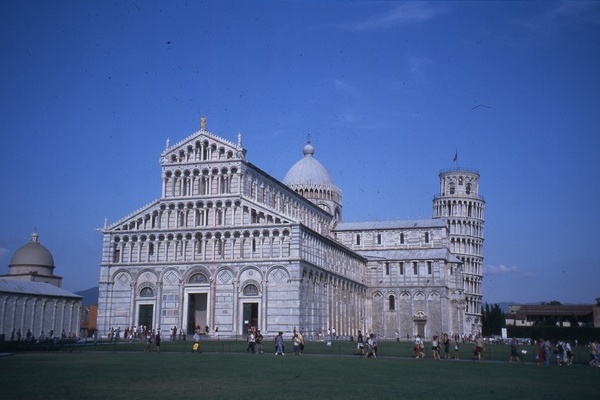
0, 0, 600, 303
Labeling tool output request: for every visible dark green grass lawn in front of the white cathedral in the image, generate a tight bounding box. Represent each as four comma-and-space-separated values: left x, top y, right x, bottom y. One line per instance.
0, 341, 600, 400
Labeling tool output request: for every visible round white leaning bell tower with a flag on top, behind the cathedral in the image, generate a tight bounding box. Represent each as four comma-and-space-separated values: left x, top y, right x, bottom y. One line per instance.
433, 167, 485, 334
